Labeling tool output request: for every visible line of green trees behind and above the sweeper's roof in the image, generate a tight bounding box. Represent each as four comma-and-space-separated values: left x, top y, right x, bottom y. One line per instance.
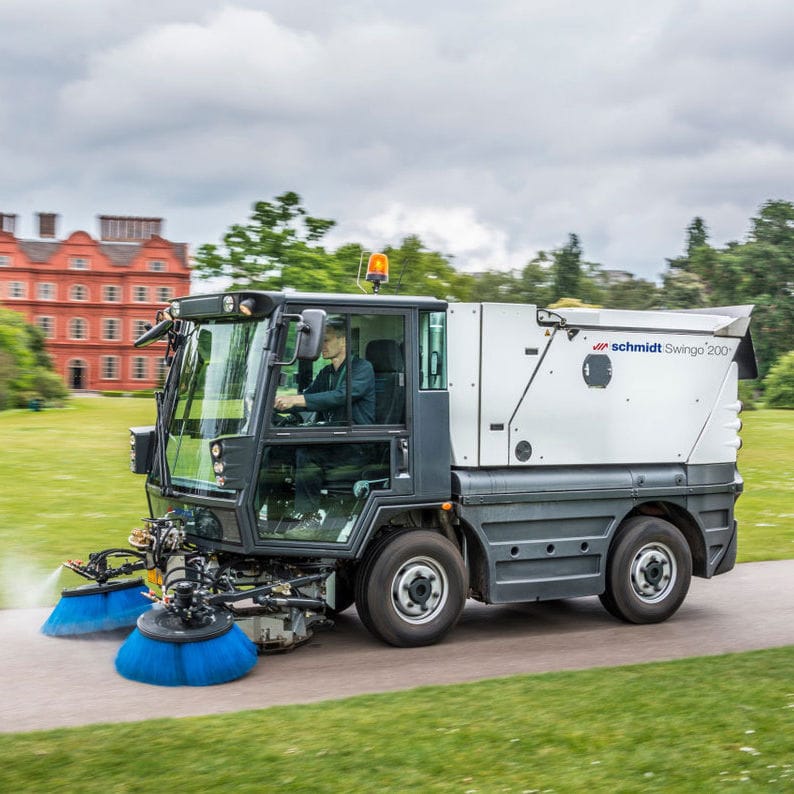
194, 191, 794, 407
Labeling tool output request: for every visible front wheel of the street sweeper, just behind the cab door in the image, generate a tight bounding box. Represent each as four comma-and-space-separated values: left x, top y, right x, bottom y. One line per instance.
356, 530, 466, 648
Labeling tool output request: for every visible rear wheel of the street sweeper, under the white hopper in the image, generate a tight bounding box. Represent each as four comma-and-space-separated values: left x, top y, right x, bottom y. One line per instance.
599, 516, 692, 623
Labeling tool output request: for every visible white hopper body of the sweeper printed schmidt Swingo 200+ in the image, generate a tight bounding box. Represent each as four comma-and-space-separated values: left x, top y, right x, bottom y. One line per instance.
449, 304, 749, 466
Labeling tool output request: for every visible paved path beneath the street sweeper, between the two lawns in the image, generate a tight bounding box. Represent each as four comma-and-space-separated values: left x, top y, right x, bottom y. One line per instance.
0, 560, 794, 732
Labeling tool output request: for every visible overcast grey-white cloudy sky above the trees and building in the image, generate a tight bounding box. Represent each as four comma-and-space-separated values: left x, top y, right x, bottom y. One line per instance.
0, 0, 794, 278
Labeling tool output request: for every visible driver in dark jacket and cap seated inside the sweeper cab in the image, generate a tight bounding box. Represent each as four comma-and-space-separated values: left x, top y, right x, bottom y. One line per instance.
274, 318, 375, 539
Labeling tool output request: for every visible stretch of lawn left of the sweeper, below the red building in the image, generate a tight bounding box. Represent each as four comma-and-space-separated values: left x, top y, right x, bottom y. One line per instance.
0, 398, 155, 607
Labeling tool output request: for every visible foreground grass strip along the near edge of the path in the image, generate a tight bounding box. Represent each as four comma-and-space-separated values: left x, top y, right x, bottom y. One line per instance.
0, 648, 794, 794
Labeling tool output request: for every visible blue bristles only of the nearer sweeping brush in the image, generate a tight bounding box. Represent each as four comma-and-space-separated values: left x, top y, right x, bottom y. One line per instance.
116, 625, 257, 686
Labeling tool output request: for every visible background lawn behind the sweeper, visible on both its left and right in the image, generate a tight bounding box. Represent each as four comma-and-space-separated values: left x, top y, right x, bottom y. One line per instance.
0, 398, 794, 607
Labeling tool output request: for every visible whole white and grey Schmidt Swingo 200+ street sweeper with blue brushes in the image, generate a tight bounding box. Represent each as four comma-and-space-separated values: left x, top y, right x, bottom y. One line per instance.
43, 256, 756, 684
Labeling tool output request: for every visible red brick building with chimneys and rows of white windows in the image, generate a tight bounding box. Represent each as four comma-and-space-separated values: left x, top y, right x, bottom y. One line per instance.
0, 213, 190, 391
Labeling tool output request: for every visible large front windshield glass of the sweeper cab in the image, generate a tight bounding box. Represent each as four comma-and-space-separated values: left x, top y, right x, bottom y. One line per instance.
166, 320, 268, 497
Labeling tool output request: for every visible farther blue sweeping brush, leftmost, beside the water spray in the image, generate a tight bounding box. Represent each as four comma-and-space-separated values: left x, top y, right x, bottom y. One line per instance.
41, 578, 152, 637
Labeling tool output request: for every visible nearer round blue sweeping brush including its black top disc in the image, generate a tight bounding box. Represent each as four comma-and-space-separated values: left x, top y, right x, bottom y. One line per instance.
116, 606, 257, 686
